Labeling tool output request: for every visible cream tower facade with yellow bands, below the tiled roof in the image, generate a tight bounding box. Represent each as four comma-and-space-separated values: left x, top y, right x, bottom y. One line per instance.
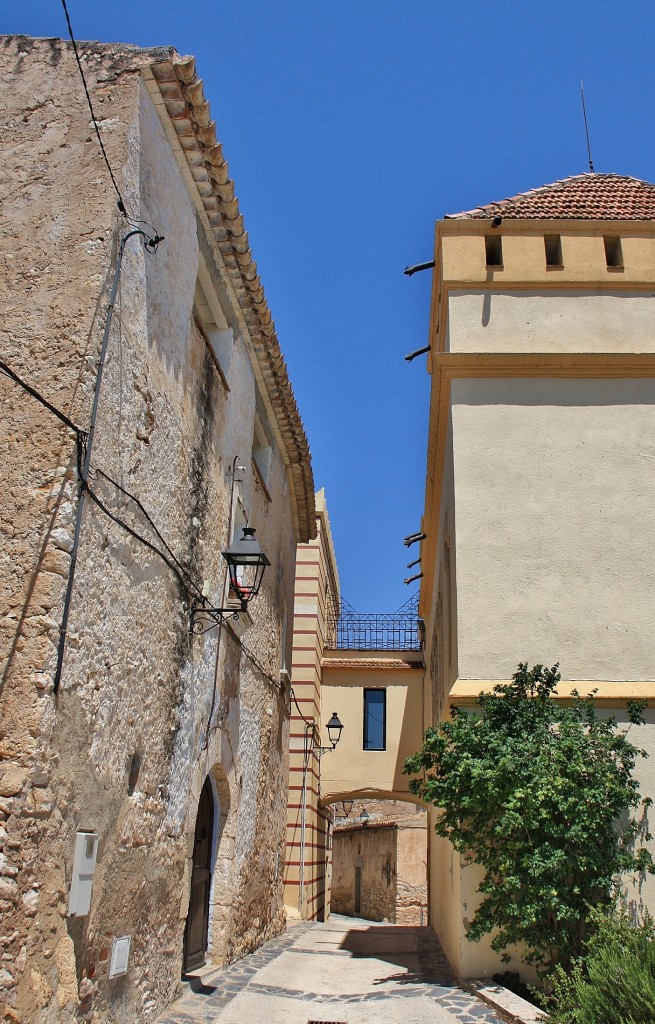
420, 211, 655, 977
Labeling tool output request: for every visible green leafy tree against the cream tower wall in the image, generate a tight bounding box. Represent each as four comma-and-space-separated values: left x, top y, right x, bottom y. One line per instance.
404, 663, 652, 973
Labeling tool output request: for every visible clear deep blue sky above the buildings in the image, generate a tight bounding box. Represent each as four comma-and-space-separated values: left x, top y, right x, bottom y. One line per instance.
5, 0, 655, 611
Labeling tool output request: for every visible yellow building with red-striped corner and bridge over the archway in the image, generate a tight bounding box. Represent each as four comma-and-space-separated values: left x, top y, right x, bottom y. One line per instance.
285, 490, 425, 921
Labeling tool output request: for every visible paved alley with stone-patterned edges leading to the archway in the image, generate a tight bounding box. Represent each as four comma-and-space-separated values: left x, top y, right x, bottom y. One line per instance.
155, 915, 506, 1024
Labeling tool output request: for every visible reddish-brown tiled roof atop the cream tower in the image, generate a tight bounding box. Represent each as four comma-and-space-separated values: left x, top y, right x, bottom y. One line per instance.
445, 173, 655, 220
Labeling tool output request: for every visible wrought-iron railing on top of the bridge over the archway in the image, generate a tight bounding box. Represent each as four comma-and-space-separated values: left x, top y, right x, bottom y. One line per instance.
328, 594, 423, 650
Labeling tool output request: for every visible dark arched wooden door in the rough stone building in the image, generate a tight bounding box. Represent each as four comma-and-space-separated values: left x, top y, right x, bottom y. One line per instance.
183, 777, 214, 972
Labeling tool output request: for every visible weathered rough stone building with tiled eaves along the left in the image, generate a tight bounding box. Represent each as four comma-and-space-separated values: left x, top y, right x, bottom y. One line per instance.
0, 37, 315, 1024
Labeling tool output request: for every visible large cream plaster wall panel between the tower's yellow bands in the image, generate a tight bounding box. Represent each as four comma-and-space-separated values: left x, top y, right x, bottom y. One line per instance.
452, 380, 655, 680
